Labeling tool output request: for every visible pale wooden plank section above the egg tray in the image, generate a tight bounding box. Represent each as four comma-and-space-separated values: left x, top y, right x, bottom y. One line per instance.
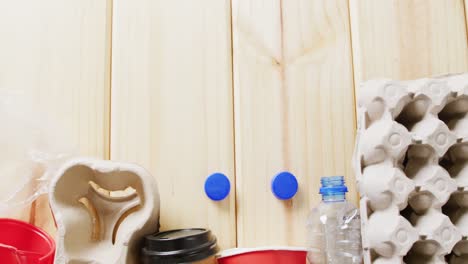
350, 0, 468, 84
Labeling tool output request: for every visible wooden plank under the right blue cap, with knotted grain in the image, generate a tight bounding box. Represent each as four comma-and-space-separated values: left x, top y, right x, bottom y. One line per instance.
233, 0, 357, 247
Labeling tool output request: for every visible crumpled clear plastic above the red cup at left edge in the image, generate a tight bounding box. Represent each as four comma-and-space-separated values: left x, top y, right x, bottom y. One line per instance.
0, 91, 74, 221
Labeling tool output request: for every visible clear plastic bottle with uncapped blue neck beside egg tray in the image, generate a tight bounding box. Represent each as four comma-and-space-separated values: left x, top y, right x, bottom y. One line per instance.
307, 176, 362, 264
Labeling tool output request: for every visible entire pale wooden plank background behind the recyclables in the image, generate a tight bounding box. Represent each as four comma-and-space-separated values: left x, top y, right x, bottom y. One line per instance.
0, 0, 468, 248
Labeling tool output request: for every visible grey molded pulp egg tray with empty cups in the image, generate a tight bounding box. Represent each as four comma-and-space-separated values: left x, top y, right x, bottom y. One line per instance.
354, 74, 468, 264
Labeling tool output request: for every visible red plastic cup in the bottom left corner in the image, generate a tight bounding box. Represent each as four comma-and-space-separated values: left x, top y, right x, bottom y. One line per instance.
0, 218, 55, 264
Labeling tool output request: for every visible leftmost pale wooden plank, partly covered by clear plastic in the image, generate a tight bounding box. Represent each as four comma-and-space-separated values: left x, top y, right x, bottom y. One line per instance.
0, 0, 111, 233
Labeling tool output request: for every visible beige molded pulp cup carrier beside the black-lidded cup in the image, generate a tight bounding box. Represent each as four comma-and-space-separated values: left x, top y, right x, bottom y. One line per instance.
49, 159, 159, 264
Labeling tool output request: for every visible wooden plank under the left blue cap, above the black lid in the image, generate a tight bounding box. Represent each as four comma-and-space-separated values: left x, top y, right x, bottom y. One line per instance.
111, 0, 236, 248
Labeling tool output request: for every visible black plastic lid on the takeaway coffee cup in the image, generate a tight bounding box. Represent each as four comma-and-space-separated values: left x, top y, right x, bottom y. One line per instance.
142, 228, 218, 264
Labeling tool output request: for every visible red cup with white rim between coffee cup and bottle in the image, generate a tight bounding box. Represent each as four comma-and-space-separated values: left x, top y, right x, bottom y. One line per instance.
218, 247, 307, 264
